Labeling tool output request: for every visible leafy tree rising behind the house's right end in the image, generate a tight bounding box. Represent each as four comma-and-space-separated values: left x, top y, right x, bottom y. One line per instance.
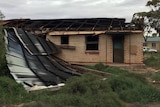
132, 0, 160, 34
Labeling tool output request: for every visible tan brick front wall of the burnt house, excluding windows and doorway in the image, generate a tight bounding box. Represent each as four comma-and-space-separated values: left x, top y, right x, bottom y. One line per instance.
47, 33, 143, 64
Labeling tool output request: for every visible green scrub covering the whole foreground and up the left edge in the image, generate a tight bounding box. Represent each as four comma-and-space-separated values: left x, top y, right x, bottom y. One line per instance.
0, 22, 160, 107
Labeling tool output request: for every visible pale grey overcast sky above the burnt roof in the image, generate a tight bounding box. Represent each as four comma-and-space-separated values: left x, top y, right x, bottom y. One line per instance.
0, 0, 149, 22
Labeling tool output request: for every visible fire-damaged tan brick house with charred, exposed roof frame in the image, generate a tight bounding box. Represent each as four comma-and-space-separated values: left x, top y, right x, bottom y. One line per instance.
1, 18, 143, 65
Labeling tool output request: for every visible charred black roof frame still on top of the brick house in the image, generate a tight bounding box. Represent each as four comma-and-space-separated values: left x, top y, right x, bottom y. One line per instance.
3, 18, 142, 32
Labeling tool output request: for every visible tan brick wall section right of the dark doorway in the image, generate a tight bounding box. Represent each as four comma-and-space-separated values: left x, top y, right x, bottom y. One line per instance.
124, 33, 143, 64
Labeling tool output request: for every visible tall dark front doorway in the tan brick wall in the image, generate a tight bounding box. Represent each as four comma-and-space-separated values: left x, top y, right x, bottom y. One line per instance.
113, 35, 124, 63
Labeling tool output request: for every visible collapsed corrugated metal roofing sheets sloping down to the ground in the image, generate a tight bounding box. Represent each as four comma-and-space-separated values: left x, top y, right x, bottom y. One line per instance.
5, 28, 80, 88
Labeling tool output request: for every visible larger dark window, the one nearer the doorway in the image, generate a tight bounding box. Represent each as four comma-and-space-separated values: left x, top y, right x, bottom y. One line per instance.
86, 36, 98, 50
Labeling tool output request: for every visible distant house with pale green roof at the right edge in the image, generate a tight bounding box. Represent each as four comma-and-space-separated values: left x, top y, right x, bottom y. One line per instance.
143, 36, 160, 51
